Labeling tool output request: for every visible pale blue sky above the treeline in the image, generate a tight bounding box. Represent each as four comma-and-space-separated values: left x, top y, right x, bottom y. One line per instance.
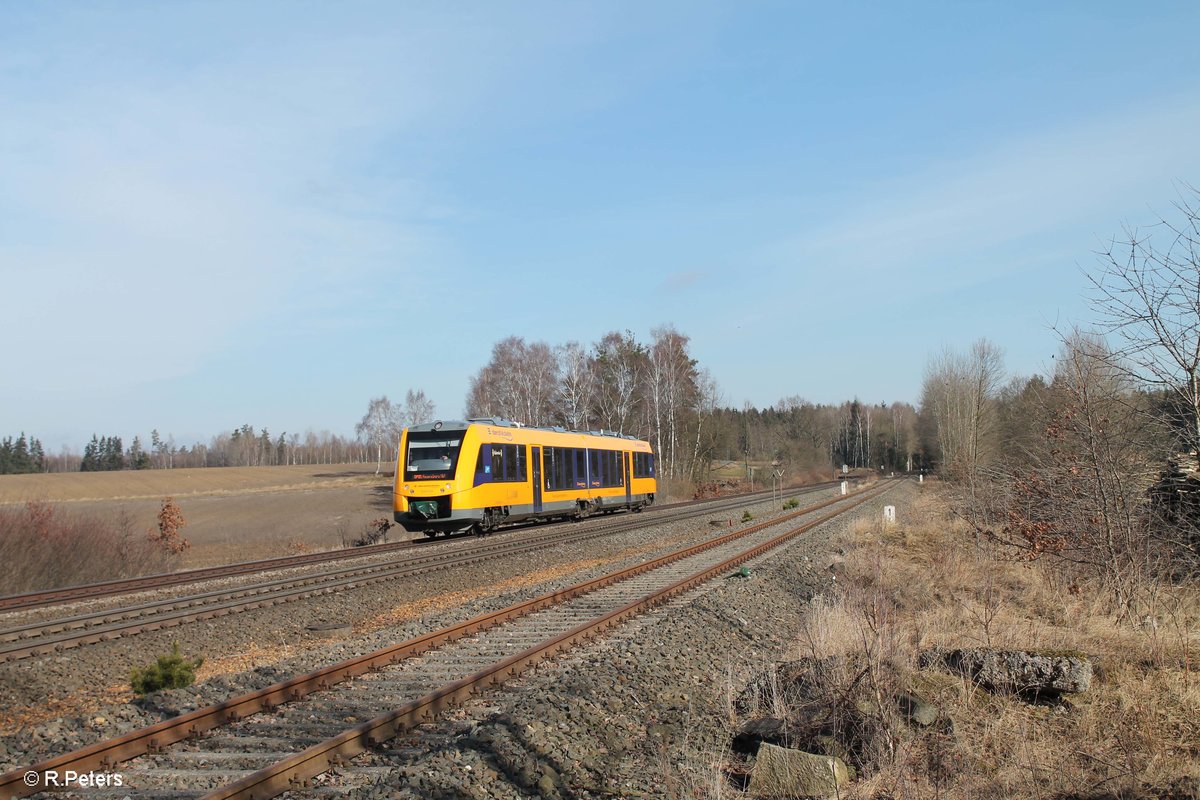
0, 0, 1200, 450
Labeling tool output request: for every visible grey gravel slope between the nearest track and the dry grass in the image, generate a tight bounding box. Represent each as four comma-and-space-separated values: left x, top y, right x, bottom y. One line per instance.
316, 485, 913, 800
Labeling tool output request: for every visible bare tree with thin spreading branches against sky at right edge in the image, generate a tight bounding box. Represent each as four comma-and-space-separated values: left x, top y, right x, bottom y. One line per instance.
1088, 187, 1200, 465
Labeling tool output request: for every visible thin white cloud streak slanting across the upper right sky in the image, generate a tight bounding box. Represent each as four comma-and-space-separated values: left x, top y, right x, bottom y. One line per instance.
762, 92, 1200, 283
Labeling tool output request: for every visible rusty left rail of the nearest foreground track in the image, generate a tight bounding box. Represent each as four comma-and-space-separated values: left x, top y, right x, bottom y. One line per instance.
0, 487, 887, 798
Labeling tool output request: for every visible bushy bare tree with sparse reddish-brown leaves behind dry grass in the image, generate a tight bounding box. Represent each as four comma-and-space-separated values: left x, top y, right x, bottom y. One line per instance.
968, 333, 1168, 615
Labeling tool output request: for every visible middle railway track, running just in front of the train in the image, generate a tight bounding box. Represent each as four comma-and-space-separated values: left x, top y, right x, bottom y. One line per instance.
0, 486, 844, 663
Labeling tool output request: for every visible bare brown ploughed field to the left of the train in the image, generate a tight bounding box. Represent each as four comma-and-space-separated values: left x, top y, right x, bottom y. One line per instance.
0, 464, 391, 568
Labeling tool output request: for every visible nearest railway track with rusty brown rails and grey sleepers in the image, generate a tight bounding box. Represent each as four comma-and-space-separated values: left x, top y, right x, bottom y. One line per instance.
0, 485, 889, 800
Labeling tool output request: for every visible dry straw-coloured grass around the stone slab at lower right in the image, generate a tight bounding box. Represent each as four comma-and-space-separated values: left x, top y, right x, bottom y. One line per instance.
797, 491, 1200, 798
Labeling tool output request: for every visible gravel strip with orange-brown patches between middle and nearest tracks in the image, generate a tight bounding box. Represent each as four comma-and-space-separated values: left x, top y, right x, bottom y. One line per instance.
0, 491, 833, 771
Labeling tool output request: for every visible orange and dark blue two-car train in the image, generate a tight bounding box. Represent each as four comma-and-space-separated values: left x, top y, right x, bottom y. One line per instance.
392, 419, 658, 536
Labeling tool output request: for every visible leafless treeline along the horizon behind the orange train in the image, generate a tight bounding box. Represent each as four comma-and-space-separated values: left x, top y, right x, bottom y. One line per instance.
0, 326, 926, 481
